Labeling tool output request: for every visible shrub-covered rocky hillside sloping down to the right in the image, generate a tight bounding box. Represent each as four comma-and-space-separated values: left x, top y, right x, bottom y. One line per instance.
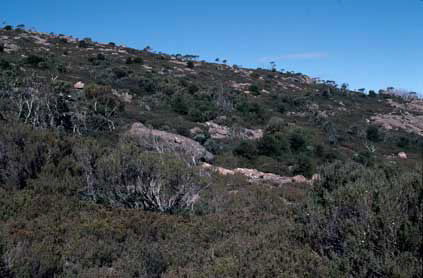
0, 26, 423, 277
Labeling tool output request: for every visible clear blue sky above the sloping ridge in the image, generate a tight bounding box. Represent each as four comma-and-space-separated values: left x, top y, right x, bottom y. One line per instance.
0, 0, 423, 92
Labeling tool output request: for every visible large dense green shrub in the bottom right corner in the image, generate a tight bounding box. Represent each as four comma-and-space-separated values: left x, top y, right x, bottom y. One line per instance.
301, 163, 423, 277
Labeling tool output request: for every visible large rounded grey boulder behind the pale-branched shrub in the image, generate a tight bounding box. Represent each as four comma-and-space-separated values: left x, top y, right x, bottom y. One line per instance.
128, 123, 214, 162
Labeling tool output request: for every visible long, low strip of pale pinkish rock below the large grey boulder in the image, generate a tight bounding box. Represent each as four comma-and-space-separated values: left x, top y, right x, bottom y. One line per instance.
201, 163, 314, 186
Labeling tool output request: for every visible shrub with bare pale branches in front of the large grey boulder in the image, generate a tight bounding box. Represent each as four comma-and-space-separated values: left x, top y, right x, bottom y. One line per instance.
79, 143, 209, 212
